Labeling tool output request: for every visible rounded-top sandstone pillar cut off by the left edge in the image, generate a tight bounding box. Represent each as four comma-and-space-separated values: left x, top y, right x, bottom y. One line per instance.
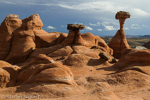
0, 14, 22, 60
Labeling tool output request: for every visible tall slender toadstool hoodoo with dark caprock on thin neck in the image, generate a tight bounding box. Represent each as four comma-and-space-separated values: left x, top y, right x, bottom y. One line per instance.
108, 11, 130, 58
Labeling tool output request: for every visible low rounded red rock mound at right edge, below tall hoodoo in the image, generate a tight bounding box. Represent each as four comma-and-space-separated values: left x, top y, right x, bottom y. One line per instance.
113, 49, 150, 74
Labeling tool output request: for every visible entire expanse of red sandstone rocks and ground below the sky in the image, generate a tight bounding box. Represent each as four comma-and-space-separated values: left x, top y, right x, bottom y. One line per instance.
0, 12, 150, 100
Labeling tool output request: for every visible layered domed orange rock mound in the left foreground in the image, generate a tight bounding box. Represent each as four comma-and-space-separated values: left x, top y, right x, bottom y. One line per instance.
17, 54, 76, 85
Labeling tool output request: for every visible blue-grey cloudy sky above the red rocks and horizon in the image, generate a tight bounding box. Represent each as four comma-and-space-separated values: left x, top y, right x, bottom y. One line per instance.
0, 0, 150, 36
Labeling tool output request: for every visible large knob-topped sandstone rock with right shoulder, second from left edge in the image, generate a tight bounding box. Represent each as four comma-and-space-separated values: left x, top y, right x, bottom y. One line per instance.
5, 14, 59, 64
